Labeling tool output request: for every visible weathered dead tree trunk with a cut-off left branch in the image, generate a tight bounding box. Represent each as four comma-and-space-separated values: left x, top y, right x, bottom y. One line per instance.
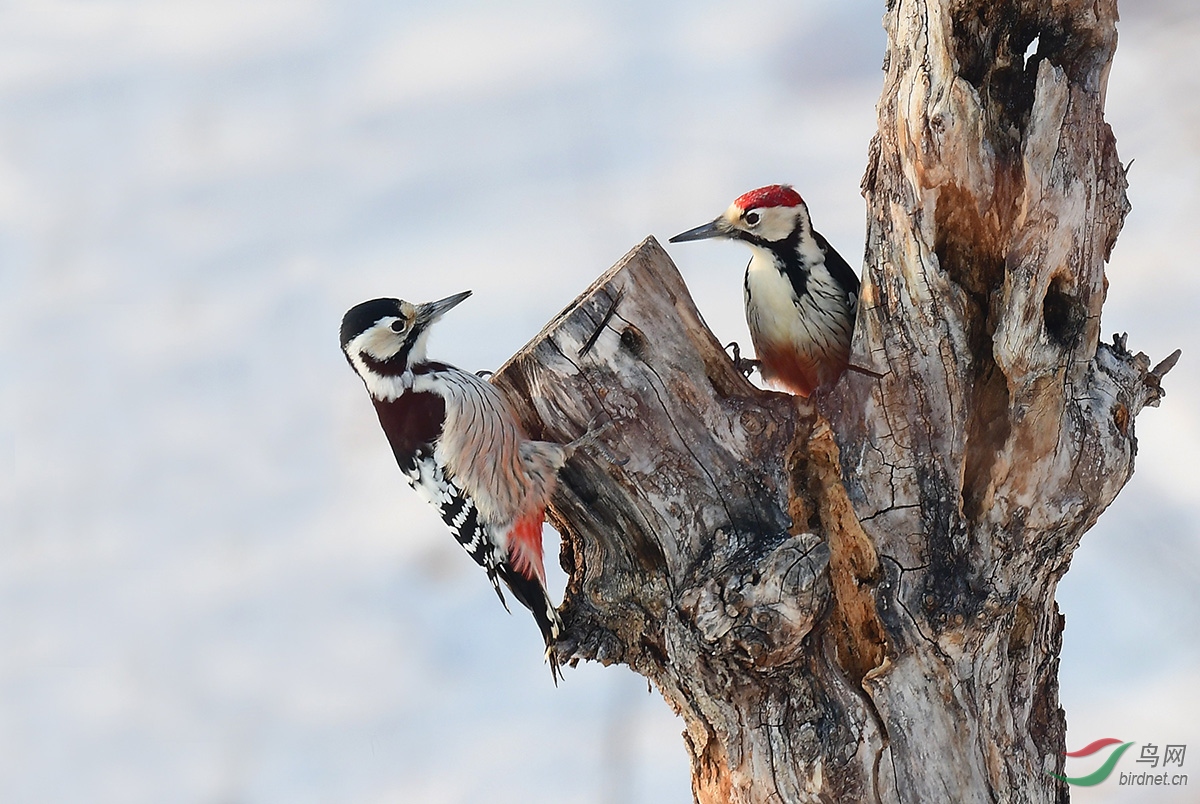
496, 0, 1169, 803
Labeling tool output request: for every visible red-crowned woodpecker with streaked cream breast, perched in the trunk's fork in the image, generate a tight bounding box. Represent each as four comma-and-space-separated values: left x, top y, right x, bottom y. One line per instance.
671, 185, 858, 396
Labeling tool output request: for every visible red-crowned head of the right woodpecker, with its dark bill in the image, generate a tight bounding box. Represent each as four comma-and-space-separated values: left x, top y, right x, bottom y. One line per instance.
671, 185, 812, 248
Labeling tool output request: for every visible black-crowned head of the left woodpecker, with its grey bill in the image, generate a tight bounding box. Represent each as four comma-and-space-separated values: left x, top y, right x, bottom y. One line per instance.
342, 290, 470, 378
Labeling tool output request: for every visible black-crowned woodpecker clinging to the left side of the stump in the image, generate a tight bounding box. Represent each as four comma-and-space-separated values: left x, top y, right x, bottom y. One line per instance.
341, 290, 573, 684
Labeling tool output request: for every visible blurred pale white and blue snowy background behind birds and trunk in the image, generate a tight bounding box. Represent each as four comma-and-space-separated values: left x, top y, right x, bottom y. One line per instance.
0, 0, 1200, 804
